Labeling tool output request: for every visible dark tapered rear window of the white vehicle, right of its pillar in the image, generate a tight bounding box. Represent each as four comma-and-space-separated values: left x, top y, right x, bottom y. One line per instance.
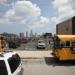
8, 54, 21, 73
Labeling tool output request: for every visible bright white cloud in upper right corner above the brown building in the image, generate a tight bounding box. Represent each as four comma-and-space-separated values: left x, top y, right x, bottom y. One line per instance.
51, 0, 75, 24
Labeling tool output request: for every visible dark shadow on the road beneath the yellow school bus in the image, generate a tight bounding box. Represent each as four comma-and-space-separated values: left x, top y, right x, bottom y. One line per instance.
45, 57, 75, 66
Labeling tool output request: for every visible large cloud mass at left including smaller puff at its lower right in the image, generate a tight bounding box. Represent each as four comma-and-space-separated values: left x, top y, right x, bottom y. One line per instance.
2, 1, 49, 30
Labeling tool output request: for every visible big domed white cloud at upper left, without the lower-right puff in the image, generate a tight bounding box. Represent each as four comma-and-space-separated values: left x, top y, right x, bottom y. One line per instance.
5, 1, 41, 21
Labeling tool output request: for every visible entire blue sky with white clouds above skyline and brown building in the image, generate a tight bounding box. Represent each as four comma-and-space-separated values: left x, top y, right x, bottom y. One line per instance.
0, 0, 75, 34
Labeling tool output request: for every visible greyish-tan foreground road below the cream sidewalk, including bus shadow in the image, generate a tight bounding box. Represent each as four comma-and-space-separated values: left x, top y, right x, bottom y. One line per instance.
22, 57, 75, 75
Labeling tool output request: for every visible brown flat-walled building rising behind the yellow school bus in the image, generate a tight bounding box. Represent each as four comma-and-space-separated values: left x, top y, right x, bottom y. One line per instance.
56, 16, 75, 35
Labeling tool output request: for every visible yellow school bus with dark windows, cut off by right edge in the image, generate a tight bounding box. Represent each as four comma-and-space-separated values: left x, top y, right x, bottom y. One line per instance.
52, 35, 75, 61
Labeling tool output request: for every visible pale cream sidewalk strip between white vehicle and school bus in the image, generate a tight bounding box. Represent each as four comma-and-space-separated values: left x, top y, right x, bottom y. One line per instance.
15, 50, 52, 58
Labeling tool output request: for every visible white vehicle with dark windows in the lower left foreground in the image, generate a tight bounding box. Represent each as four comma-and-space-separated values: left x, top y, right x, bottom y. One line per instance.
0, 52, 22, 75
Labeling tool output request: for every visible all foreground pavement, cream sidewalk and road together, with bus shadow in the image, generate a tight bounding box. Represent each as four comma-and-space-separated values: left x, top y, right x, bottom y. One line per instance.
12, 50, 75, 75
